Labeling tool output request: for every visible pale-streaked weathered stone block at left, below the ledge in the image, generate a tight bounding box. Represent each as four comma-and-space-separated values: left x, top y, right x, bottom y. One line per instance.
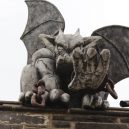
0, 111, 49, 127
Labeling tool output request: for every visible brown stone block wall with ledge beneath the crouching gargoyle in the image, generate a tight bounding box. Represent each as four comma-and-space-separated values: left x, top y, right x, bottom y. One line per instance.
0, 104, 129, 129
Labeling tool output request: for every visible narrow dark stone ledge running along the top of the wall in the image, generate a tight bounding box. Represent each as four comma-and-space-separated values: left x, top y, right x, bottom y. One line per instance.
0, 101, 129, 116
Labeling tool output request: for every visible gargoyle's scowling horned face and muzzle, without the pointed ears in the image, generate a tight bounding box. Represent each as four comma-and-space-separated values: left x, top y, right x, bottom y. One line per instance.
55, 30, 83, 69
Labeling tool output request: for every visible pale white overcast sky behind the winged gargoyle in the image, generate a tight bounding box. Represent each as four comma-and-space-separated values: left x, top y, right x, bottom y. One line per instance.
0, 0, 129, 106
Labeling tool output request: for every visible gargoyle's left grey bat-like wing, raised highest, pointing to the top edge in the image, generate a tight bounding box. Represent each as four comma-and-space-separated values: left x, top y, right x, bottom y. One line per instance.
21, 0, 65, 64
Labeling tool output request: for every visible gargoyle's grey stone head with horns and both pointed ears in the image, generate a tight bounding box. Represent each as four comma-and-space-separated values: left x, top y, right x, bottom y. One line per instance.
39, 29, 101, 72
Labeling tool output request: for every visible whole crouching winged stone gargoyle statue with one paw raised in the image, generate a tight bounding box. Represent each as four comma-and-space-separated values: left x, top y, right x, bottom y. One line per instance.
19, 0, 129, 108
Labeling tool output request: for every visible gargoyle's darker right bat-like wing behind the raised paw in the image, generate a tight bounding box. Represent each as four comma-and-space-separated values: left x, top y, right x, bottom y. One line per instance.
92, 25, 129, 83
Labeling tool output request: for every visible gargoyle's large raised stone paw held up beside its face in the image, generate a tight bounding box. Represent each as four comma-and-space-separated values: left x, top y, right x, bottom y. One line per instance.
68, 47, 110, 91
